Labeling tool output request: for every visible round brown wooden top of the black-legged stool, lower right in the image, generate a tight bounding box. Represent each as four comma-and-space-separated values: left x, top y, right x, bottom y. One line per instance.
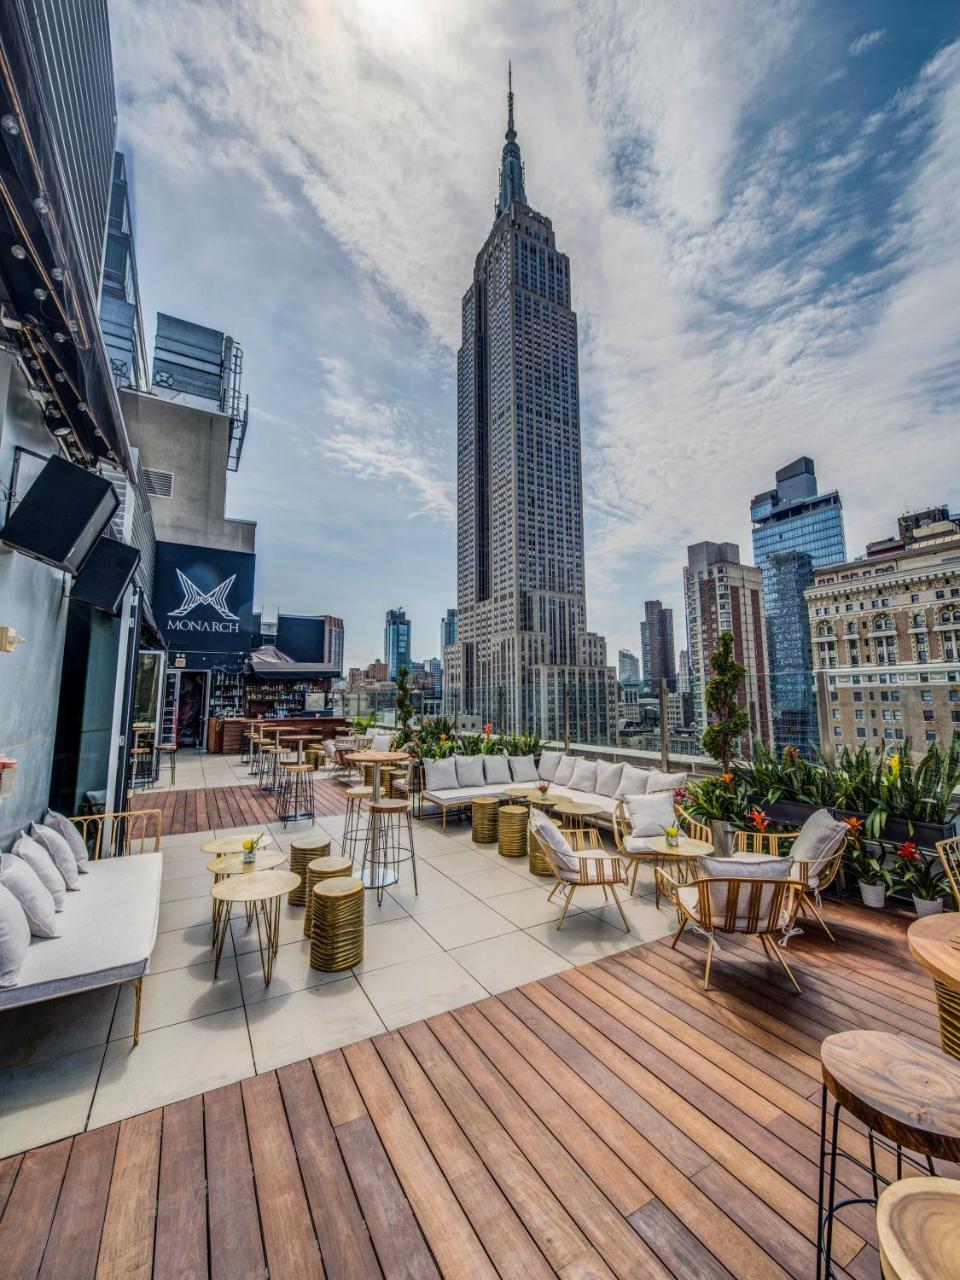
820, 1030, 960, 1161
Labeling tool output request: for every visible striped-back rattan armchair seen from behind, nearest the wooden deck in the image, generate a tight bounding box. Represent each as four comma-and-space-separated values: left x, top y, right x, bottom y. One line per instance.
654, 868, 805, 992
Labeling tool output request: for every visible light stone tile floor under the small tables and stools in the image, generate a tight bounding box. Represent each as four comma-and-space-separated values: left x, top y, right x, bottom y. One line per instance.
0, 751, 673, 1157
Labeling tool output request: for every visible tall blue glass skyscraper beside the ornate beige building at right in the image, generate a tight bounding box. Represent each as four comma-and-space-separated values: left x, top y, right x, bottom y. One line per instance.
750, 458, 846, 756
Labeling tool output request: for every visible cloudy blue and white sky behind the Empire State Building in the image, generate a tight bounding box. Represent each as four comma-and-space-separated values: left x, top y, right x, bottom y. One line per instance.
111, 0, 960, 663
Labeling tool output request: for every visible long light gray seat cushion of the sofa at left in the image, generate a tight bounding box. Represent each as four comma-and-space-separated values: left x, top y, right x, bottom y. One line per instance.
0, 854, 163, 1009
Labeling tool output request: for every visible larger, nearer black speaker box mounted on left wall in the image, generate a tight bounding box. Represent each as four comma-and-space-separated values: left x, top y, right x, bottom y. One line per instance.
0, 457, 120, 573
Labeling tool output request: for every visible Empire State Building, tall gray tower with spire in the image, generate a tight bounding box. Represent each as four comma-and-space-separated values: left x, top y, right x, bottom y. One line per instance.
444, 70, 617, 742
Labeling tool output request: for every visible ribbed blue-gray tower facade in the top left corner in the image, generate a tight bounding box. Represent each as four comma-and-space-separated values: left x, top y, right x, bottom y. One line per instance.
25, 0, 116, 298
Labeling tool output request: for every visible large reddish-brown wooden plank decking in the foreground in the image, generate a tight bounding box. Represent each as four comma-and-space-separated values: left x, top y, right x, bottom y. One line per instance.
0, 908, 952, 1280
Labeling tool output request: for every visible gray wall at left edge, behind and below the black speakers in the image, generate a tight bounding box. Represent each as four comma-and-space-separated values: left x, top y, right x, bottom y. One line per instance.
0, 351, 68, 849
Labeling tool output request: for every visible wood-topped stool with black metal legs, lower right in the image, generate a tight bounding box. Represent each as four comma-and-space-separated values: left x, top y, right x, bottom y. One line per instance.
817, 1030, 960, 1280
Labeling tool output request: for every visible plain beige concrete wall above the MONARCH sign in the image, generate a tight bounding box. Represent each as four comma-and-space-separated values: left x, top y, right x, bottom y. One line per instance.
120, 390, 256, 552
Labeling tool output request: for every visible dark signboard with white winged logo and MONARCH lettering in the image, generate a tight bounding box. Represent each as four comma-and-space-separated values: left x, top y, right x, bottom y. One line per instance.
152, 543, 256, 654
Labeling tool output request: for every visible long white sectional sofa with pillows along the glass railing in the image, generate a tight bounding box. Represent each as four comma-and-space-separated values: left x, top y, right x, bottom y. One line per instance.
422, 751, 686, 829
